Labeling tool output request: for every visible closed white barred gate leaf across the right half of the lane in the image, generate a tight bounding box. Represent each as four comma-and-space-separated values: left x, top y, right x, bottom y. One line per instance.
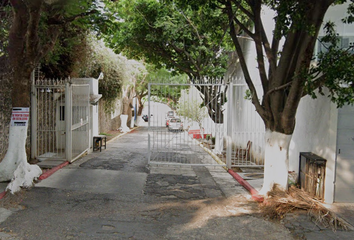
148, 83, 227, 166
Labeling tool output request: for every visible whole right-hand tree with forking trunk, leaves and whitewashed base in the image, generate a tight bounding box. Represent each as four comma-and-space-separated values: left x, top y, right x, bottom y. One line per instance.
219, 0, 354, 193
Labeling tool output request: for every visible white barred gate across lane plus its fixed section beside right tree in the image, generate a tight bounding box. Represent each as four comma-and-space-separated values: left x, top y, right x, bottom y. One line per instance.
148, 79, 264, 168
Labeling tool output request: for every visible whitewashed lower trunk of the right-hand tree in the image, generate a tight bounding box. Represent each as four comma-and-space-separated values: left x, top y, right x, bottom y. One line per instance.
260, 129, 292, 195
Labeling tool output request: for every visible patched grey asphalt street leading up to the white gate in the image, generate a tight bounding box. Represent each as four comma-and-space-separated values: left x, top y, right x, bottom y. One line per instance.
0, 127, 338, 240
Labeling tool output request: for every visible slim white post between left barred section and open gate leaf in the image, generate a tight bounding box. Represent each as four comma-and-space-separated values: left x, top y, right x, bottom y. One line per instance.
65, 83, 72, 161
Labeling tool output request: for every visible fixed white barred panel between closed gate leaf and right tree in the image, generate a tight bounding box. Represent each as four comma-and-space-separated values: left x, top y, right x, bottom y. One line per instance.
228, 81, 265, 167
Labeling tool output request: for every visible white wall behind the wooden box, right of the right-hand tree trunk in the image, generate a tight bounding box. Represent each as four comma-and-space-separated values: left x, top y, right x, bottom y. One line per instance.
289, 91, 338, 203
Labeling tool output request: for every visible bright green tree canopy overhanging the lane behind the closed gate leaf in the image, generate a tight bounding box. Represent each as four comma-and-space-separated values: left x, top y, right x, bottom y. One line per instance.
102, 0, 232, 77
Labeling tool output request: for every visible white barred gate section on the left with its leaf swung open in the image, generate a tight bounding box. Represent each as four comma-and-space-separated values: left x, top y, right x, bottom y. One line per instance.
31, 79, 90, 161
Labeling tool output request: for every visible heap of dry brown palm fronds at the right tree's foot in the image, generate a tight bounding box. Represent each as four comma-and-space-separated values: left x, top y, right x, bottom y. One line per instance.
261, 185, 351, 231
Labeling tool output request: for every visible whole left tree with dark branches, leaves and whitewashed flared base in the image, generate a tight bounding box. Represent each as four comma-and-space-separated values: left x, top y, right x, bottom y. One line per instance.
0, 0, 104, 191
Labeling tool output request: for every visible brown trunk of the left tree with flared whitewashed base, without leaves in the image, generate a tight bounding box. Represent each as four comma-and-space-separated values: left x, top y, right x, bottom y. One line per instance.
0, 0, 58, 193
